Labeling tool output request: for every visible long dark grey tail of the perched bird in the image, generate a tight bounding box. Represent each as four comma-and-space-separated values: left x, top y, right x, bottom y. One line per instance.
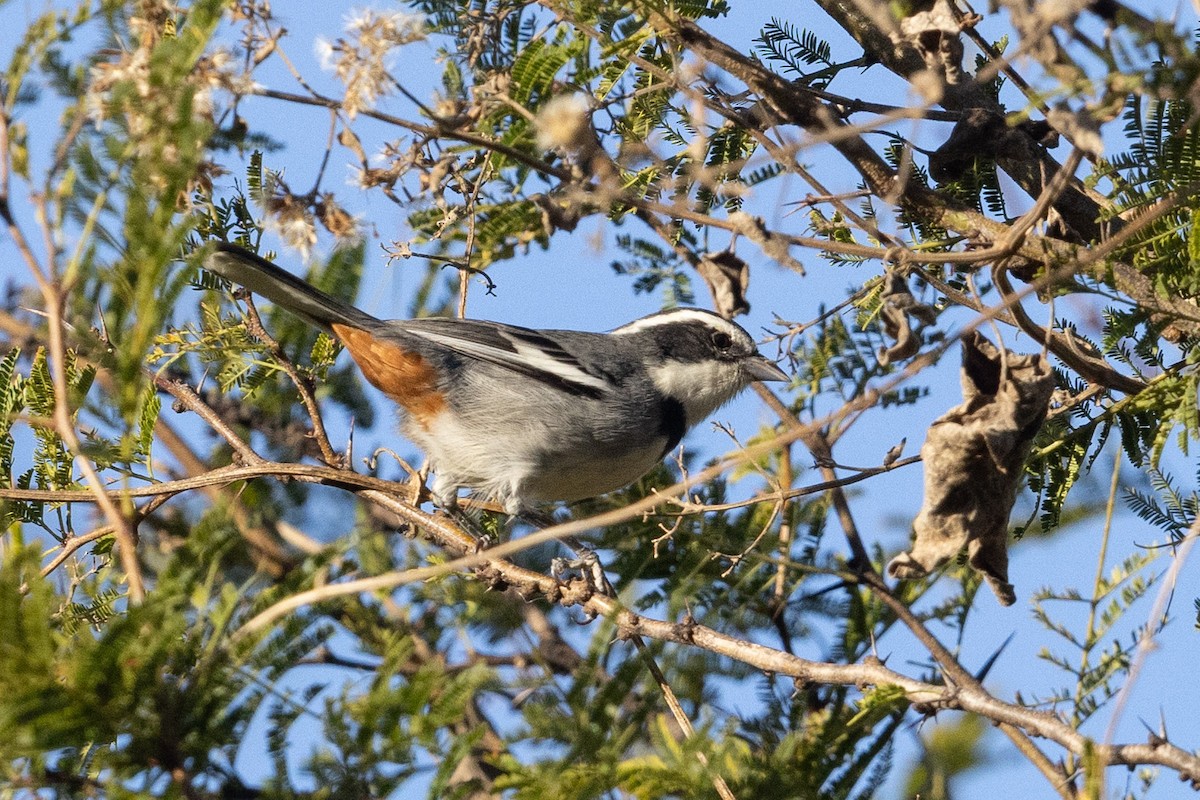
204, 242, 379, 331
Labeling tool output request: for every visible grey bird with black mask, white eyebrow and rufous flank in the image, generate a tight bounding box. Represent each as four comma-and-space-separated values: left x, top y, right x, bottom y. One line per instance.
204, 242, 788, 516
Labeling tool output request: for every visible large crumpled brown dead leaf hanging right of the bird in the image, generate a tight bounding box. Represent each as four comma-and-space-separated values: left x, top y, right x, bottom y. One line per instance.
888, 333, 1054, 606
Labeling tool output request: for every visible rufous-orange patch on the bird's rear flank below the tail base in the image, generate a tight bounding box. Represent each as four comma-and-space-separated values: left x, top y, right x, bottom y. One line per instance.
332, 324, 446, 427
